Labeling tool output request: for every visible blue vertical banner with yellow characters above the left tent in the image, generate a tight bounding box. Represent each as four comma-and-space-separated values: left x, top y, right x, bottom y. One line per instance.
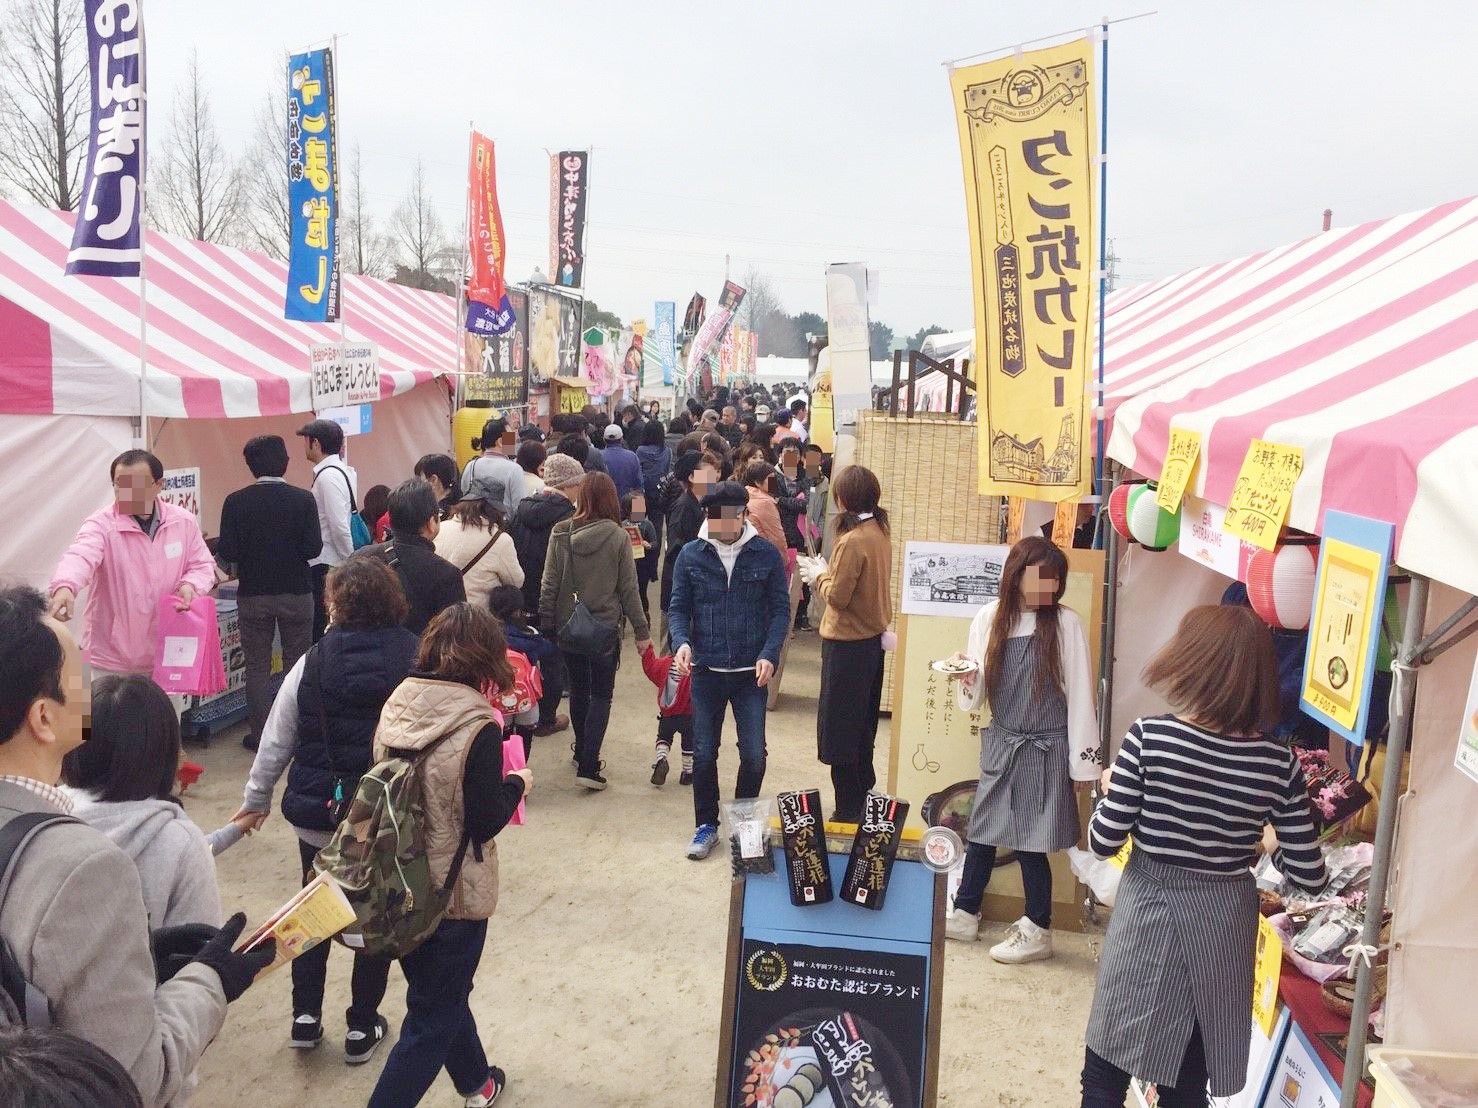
282, 50, 338, 324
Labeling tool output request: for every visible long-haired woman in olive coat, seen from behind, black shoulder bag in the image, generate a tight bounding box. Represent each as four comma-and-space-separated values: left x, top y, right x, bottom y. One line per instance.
539, 473, 652, 790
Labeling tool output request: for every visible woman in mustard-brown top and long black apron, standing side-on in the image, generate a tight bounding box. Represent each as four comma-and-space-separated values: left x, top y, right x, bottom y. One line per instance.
800, 465, 893, 823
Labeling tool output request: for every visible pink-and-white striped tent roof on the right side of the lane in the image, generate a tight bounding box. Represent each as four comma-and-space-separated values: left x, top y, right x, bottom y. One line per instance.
1104, 198, 1478, 594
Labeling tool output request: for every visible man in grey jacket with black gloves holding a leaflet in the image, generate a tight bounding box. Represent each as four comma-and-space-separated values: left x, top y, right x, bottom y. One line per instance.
0, 588, 273, 1105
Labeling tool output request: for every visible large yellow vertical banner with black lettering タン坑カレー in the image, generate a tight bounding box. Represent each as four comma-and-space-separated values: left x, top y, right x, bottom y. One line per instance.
949, 38, 1098, 502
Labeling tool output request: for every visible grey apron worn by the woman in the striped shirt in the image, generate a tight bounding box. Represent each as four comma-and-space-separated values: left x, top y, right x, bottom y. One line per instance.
1088, 849, 1258, 1096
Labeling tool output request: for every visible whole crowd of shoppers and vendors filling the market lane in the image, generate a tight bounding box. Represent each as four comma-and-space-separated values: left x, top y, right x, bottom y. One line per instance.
0, 375, 1323, 1108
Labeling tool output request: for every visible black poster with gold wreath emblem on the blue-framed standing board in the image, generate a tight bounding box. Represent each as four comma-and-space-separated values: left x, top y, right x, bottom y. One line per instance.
727, 940, 928, 1108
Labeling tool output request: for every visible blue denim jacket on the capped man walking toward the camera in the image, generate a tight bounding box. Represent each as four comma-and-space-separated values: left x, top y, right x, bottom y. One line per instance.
667, 535, 791, 669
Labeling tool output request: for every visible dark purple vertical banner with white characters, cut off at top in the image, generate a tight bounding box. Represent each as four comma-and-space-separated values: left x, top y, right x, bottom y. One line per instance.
67, 0, 145, 276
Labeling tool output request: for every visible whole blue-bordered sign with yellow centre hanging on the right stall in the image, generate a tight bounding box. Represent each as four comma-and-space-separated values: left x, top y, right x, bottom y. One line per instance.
1299, 511, 1395, 746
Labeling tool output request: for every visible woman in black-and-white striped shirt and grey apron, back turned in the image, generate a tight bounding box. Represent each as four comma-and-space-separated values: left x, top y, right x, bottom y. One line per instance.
1083, 607, 1324, 1108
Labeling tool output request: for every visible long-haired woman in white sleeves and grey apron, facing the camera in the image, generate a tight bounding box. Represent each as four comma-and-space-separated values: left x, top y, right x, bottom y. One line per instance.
946, 536, 1100, 965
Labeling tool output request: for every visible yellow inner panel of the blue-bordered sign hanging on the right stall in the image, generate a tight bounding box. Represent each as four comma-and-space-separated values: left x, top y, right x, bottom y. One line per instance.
1304, 538, 1385, 731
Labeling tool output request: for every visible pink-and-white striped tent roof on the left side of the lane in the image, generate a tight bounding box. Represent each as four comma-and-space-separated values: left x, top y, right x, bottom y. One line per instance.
0, 201, 457, 418
